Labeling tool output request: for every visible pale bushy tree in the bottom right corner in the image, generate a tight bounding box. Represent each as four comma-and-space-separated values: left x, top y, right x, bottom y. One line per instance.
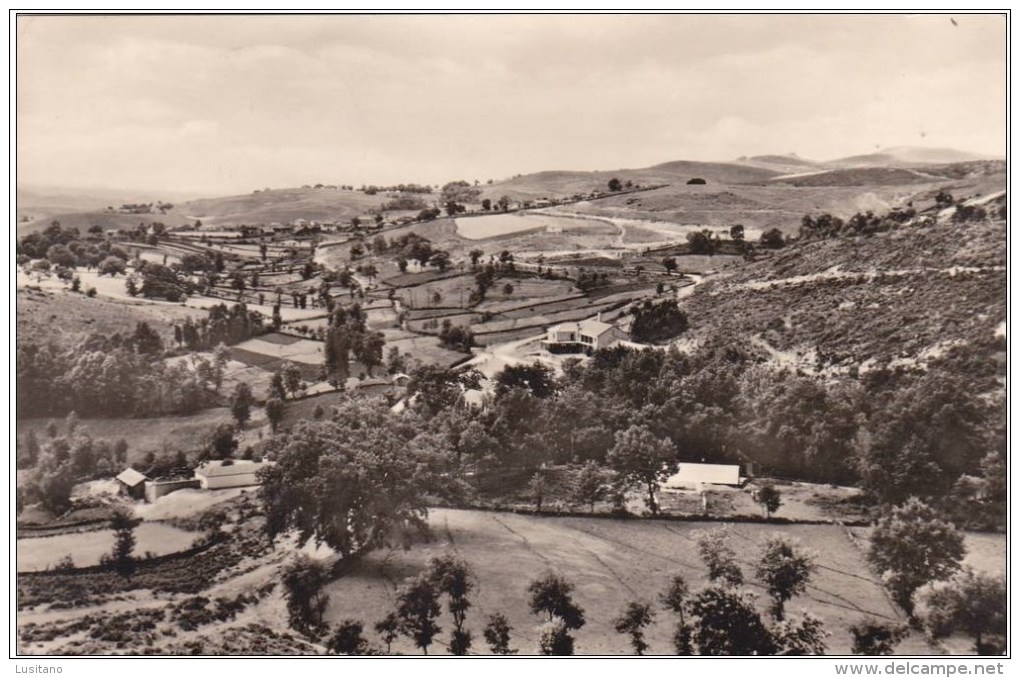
924, 568, 1009, 655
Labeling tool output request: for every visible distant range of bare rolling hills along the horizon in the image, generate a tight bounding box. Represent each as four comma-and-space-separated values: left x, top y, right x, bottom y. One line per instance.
17, 142, 1005, 233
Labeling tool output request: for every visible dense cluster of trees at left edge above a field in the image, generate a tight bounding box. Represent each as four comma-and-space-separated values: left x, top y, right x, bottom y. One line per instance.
16, 323, 224, 417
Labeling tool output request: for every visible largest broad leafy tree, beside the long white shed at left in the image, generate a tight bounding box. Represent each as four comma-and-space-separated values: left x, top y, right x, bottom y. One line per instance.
259, 418, 452, 560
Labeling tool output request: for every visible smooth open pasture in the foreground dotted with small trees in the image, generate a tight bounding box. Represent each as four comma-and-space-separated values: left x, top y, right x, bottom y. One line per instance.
318, 510, 946, 655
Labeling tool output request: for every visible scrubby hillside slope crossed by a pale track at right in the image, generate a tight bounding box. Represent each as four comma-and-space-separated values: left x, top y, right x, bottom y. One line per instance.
684, 221, 1007, 374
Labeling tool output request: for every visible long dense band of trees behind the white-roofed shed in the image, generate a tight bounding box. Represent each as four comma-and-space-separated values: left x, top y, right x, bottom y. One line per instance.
393, 343, 1005, 513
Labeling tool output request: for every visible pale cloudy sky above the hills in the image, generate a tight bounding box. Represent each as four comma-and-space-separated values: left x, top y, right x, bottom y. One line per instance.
16, 14, 1007, 195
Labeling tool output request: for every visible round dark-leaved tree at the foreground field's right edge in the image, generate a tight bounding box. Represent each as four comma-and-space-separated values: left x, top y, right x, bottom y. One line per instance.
868, 498, 964, 619
